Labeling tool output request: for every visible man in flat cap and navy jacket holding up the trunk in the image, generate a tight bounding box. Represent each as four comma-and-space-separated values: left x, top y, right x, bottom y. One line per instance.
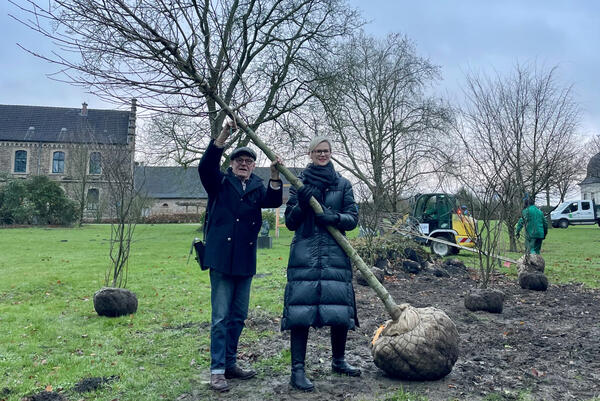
198, 119, 283, 391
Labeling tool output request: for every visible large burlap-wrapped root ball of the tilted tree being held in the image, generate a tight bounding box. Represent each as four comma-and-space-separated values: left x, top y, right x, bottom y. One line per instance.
371, 304, 459, 380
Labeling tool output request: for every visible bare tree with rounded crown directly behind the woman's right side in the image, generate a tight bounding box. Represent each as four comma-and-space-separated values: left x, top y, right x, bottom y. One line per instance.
316, 35, 452, 212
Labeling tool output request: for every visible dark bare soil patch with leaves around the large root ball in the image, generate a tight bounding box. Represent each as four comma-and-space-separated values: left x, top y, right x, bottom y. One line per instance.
178, 262, 600, 401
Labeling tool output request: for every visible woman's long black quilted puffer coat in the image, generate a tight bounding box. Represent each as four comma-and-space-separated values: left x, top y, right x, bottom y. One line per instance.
281, 174, 358, 330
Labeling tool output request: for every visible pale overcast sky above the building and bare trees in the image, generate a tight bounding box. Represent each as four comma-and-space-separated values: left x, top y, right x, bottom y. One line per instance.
0, 0, 600, 135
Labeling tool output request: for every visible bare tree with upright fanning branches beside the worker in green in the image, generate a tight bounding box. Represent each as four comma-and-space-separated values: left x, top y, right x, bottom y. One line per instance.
460, 65, 580, 251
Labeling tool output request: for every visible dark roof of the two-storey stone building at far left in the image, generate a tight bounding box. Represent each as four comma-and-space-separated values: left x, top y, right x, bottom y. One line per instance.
0, 105, 130, 144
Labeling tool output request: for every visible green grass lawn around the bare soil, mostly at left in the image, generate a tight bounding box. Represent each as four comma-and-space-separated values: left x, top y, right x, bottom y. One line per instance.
0, 225, 600, 401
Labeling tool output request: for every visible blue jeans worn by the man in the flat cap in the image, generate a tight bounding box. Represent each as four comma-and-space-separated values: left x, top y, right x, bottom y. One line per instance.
210, 269, 252, 374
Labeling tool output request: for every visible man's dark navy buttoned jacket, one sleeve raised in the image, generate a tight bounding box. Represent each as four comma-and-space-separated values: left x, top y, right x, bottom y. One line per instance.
198, 141, 283, 276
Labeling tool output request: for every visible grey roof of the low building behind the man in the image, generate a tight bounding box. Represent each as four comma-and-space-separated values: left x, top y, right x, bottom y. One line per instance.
134, 166, 303, 199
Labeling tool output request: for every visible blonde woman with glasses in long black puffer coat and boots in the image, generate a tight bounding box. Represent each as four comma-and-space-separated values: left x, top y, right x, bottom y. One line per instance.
281, 137, 361, 391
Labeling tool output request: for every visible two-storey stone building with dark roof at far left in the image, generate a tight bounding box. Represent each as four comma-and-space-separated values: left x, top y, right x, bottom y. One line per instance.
0, 99, 136, 220
